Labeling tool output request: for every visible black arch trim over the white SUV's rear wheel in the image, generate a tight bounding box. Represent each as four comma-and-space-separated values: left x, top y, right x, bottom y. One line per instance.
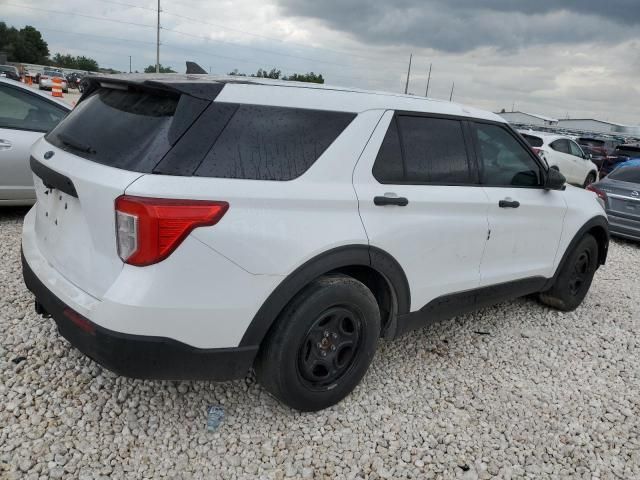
239, 245, 411, 347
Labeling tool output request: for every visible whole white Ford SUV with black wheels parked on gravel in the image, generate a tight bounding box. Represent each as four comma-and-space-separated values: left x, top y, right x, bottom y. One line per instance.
22, 75, 608, 410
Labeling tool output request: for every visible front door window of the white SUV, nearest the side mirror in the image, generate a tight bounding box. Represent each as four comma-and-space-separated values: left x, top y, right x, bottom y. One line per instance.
475, 123, 542, 187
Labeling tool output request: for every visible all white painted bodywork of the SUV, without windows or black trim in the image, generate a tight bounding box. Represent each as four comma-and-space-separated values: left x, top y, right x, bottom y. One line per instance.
23, 79, 603, 348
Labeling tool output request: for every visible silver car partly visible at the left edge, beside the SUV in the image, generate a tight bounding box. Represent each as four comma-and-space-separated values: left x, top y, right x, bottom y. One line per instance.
0, 78, 71, 206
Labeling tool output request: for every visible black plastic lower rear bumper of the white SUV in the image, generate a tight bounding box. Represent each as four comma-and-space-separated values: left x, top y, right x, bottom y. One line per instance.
22, 255, 258, 381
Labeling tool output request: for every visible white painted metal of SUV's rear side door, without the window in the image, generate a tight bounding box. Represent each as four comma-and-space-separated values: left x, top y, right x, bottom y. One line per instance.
353, 111, 488, 310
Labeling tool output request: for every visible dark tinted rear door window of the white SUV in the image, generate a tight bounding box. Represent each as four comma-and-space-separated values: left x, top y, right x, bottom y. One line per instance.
373, 116, 471, 185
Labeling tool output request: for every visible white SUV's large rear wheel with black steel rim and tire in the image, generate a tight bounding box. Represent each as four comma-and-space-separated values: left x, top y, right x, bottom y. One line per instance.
255, 275, 380, 412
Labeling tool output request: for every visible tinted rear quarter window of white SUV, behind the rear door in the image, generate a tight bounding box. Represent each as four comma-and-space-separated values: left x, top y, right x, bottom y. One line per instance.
195, 105, 355, 180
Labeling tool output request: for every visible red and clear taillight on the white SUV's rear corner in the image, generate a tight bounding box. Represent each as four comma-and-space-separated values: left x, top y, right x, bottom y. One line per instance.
116, 195, 229, 267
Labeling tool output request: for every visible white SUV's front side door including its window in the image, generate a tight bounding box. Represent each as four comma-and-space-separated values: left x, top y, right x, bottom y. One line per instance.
472, 122, 567, 286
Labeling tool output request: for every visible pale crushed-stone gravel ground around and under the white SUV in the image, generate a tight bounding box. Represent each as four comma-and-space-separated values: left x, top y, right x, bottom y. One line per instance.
0, 210, 640, 479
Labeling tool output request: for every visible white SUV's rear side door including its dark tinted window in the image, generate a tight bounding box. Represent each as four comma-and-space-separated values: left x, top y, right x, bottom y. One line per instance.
353, 111, 488, 311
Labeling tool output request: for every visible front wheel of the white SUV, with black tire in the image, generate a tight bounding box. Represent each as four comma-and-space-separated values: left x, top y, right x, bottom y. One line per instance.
540, 234, 598, 312
